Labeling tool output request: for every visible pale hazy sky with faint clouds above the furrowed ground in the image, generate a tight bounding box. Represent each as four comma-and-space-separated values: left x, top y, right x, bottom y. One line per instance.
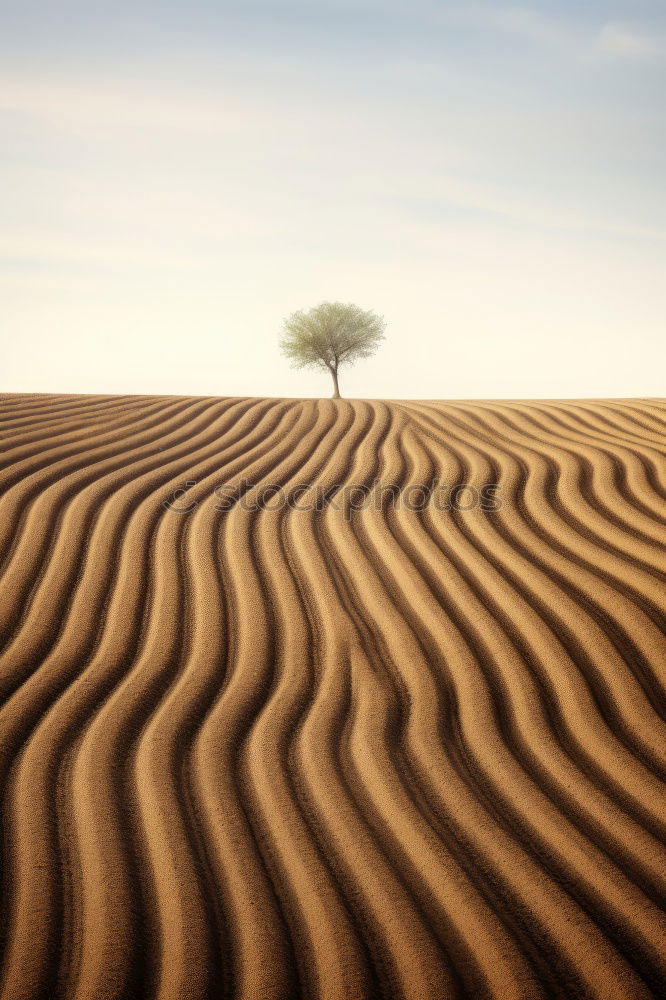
0, 0, 666, 398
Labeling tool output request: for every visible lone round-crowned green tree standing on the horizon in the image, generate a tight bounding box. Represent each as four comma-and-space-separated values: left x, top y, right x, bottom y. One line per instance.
280, 302, 386, 399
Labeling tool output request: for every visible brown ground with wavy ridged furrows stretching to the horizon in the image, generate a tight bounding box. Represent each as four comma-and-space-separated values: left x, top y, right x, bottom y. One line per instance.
0, 395, 666, 1000
